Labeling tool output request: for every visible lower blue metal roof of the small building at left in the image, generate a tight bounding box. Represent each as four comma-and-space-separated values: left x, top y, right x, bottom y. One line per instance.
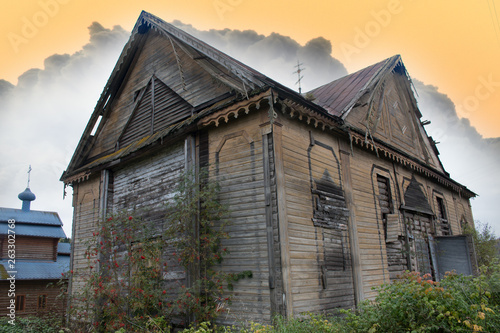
0, 256, 70, 280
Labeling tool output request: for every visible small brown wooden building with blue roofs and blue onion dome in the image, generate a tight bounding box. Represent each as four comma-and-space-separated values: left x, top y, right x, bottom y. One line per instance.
0, 187, 71, 319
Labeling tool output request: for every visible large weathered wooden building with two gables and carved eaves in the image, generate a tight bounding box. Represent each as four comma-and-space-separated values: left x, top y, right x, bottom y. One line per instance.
61, 12, 475, 323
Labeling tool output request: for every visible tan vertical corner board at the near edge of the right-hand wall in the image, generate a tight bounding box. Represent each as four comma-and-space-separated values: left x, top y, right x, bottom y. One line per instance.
272, 122, 293, 317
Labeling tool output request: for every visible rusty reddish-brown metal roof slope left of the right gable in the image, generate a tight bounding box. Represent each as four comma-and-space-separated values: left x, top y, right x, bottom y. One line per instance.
308, 55, 401, 117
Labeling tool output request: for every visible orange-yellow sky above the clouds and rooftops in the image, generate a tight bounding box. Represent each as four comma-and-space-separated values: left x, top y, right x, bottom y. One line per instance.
0, 0, 500, 137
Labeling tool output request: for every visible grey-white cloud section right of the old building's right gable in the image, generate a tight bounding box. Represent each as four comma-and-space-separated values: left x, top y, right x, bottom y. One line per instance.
413, 79, 500, 228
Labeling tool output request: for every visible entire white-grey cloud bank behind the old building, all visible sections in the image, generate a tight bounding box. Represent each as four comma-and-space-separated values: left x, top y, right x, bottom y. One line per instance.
0, 21, 500, 236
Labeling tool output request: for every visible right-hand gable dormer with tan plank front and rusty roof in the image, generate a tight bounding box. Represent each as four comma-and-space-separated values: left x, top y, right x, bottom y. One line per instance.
311, 55, 445, 173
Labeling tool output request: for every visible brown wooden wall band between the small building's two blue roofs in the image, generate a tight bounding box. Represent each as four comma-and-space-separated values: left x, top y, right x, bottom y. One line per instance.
0, 236, 59, 261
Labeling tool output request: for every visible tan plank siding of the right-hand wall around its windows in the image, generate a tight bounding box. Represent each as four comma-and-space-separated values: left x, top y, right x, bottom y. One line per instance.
274, 109, 471, 300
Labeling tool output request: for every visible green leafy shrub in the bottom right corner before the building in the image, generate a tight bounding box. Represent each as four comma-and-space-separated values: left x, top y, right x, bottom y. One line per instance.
343, 272, 500, 332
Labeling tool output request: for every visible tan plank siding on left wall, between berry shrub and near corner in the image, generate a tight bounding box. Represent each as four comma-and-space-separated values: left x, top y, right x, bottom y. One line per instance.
209, 110, 281, 324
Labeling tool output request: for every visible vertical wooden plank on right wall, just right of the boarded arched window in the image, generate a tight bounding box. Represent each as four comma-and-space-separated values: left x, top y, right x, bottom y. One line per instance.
339, 140, 364, 305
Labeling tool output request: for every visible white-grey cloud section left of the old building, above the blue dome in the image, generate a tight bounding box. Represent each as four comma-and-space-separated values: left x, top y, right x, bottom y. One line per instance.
0, 22, 129, 233
